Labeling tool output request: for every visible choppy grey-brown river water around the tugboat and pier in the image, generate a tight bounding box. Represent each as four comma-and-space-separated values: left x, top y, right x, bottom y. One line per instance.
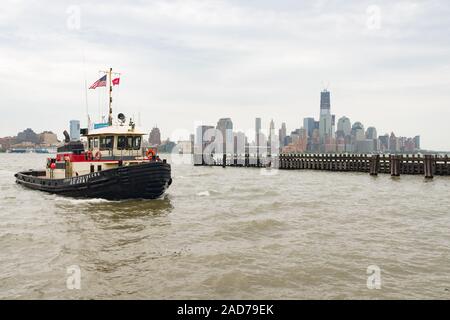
0, 154, 450, 299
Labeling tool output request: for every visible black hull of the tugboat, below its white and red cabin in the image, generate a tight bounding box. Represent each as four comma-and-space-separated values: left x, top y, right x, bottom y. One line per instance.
15, 162, 172, 200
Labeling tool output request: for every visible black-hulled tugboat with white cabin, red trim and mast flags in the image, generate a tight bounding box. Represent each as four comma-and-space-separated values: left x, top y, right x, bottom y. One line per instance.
15, 69, 172, 200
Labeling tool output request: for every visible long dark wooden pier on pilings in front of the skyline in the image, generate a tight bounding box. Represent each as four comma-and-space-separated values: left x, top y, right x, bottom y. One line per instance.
194, 153, 450, 179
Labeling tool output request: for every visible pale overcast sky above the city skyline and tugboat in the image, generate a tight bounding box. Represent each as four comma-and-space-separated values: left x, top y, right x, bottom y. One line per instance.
0, 0, 450, 150
